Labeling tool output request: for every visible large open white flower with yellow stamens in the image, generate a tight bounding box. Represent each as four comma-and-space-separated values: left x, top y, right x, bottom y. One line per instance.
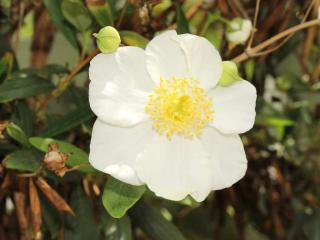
89, 31, 256, 201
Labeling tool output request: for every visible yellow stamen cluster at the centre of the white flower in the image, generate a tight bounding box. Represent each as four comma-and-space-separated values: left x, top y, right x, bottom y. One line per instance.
145, 77, 213, 139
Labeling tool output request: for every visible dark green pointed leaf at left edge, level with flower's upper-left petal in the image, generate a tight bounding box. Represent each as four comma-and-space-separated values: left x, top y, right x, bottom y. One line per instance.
0, 76, 53, 102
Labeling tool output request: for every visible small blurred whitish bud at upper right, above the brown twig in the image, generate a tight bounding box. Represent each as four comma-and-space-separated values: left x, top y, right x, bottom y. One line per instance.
226, 18, 252, 44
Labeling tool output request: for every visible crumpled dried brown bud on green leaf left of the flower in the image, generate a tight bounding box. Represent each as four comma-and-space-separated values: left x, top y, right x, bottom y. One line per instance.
43, 144, 68, 177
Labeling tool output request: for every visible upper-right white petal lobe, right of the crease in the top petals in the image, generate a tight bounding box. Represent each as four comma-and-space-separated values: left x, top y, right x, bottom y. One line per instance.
178, 34, 222, 89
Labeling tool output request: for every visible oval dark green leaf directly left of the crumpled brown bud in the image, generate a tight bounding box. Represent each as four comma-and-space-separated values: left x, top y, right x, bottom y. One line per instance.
4, 149, 41, 172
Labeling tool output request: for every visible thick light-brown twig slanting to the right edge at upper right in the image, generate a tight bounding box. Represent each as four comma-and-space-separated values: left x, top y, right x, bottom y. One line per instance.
232, 19, 320, 63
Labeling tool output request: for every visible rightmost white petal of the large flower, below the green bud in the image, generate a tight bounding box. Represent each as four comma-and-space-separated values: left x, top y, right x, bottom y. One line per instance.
209, 81, 257, 134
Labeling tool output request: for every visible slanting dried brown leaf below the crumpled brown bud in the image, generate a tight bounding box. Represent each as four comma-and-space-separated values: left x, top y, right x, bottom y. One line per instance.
36, 177, 75, 215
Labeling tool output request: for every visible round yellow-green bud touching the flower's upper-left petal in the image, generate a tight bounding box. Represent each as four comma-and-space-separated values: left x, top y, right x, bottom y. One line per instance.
93, 26, 121, 53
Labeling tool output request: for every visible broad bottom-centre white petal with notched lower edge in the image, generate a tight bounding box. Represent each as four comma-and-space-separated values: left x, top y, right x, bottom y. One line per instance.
136, 135, 213, 201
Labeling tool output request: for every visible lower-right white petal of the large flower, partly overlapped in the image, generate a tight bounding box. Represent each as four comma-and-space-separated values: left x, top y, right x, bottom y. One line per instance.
200, 127, 247, 190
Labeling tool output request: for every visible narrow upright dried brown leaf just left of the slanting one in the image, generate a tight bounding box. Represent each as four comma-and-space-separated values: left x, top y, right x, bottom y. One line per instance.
29, 178, 42, 240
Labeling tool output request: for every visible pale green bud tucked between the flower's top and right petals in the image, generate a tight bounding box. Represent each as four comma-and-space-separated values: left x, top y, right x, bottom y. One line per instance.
218, 61, 242, 87
